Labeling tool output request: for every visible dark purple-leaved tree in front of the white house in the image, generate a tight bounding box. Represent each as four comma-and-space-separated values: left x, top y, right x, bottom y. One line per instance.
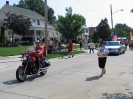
3, 12, 31, 42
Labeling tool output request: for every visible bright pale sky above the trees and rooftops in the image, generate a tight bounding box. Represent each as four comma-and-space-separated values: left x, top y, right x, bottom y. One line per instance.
0, 0, 133, 28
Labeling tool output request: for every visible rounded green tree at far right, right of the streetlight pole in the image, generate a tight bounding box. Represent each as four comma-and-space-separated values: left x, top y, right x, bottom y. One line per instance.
115, 23, 131, 38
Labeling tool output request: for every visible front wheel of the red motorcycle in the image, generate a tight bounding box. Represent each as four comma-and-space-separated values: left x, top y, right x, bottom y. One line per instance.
16, 67, 27, 82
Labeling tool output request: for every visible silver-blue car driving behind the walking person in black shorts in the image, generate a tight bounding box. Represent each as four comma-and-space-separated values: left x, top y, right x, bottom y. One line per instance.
105, 41, 126, 55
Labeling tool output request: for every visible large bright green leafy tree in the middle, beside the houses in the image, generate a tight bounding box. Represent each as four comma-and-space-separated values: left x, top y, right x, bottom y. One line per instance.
55, 7, 86, 40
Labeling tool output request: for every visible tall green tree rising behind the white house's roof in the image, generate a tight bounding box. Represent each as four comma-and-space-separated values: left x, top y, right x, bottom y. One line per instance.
13, 0, 56, 21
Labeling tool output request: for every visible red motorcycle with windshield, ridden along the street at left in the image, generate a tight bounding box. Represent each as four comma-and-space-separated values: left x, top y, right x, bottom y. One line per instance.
16, 48, 50, 82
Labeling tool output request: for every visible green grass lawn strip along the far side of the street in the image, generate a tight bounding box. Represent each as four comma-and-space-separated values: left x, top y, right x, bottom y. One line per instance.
0, 45, 84, 59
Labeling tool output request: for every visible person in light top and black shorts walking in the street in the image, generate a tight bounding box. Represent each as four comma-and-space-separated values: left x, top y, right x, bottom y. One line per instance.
97, 42, 109, 77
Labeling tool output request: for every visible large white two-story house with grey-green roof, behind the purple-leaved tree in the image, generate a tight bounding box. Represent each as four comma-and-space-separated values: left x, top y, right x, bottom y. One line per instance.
0, 1, 57, 40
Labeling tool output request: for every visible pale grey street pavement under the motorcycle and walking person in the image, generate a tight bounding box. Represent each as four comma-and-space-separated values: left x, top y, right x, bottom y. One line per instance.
0, 51, 133, 99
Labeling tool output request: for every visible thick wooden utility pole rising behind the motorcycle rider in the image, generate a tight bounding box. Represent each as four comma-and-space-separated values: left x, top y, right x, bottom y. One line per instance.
44, 0, 48, 56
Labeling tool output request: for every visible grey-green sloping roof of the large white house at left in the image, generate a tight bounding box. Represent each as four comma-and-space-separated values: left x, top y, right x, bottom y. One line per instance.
7, 5, 44, 19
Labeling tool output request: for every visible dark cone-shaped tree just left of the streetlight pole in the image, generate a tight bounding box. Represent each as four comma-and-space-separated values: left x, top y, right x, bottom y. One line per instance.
96, 18, 111, 40
